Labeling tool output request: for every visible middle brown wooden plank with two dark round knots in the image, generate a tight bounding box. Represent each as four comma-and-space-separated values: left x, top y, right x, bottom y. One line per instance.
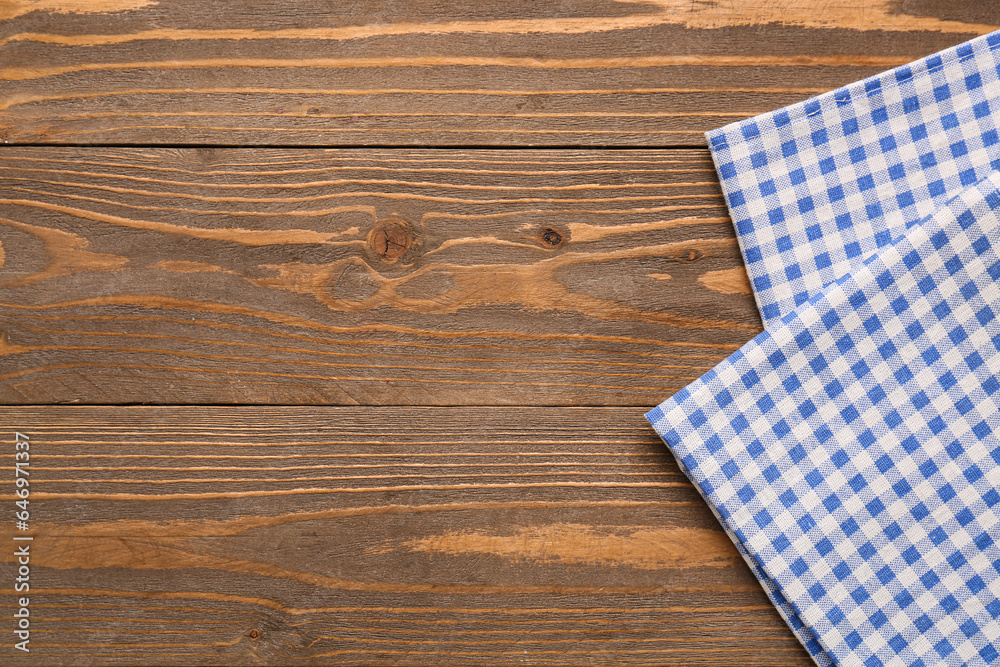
0, 148, 760, 406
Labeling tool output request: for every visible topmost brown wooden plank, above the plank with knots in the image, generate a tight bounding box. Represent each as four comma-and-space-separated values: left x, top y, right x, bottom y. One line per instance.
0, 0, 1000, 147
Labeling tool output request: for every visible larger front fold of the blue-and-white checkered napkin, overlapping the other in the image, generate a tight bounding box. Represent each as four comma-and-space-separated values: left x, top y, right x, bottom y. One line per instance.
647, 173, 1000, 667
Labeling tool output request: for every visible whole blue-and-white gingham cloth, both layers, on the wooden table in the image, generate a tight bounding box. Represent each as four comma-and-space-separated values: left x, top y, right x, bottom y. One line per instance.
647, 28, 1000, 666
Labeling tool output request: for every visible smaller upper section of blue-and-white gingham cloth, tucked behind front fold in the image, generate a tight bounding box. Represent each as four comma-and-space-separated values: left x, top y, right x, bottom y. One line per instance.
707, 32, 1000, 326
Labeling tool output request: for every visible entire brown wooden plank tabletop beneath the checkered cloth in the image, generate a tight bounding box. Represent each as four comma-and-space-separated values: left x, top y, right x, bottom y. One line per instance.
0, 0, 1000, 665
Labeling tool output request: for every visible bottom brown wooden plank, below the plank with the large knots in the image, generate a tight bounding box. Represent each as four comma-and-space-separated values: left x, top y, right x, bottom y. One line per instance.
0, 406, 811, 665
